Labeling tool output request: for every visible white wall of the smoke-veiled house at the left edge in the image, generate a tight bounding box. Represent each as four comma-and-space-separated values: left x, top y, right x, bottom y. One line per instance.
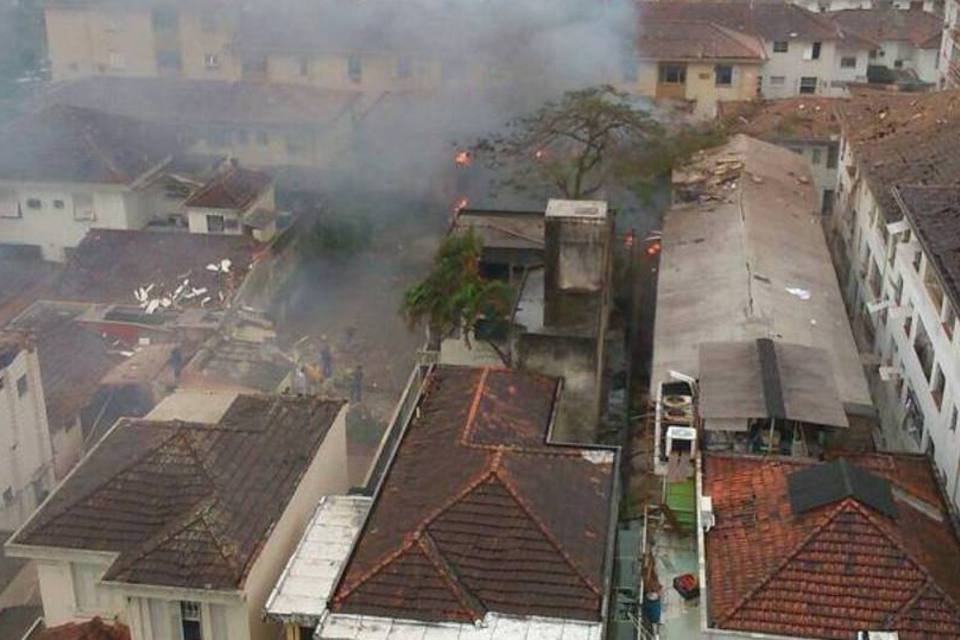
0, 182, 146, 261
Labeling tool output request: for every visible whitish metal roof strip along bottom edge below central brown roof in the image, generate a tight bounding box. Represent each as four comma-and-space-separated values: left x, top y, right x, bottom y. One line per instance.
315, 612, 603, 640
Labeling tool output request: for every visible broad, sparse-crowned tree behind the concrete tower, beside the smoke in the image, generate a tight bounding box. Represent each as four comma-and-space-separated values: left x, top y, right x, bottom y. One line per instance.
471, 86, 662, 199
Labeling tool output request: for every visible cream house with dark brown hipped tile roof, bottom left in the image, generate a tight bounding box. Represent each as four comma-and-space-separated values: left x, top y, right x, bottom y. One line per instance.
6, 391, 349, 640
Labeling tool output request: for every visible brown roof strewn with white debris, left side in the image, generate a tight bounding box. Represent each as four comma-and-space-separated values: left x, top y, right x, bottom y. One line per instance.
54, 229, 262, 308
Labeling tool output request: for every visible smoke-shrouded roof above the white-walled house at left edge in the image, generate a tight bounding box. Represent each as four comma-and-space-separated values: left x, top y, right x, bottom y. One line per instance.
0, 105, 180, 184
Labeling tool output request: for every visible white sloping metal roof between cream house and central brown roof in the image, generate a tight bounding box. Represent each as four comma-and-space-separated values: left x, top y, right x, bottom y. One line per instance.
266, 496, 371, 622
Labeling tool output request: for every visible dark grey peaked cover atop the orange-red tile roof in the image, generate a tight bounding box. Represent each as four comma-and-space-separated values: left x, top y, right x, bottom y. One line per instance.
787, 458, 897, 518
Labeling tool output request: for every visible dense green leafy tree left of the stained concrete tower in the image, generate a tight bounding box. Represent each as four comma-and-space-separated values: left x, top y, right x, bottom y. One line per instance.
400, 229, 513, 360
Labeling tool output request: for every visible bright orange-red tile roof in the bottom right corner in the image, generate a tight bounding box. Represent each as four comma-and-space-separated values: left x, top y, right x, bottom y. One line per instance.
703, 454, 960, 640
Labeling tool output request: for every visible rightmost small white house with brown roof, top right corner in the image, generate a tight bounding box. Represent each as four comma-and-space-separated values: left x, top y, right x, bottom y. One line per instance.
827, 9, 943, 85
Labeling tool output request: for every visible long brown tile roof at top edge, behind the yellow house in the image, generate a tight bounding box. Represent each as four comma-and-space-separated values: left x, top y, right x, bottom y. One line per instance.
637, 1, 843, 42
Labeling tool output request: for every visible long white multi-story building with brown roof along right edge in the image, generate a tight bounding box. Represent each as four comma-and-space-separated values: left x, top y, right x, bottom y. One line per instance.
833, 91, 960, 503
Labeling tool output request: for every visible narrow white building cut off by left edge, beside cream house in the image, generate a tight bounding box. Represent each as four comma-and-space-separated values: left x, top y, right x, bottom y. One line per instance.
0, 332, 54, 531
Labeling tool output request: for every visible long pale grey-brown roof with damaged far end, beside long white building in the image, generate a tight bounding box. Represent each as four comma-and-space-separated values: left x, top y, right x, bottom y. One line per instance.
651, 135, 872, 406
